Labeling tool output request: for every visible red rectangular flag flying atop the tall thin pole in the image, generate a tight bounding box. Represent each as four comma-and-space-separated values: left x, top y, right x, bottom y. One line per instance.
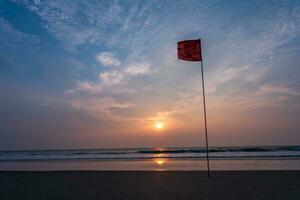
178, 39, 202, 61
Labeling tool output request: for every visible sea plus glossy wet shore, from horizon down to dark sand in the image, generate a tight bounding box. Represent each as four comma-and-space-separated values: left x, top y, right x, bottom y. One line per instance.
0, 146, 300, 170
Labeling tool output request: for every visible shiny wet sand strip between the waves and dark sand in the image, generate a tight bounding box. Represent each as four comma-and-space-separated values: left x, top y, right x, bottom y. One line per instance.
0, 158, 300, 171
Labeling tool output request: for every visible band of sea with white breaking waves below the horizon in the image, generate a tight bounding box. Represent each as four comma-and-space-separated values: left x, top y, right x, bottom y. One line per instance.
0, 146, 300, 161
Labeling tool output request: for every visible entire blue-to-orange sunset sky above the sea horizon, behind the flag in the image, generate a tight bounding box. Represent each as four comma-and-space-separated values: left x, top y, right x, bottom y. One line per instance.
0, 0, 300, 150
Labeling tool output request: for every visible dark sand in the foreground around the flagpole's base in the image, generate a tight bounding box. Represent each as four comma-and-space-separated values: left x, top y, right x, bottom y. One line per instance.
0, 171, 300, 200
